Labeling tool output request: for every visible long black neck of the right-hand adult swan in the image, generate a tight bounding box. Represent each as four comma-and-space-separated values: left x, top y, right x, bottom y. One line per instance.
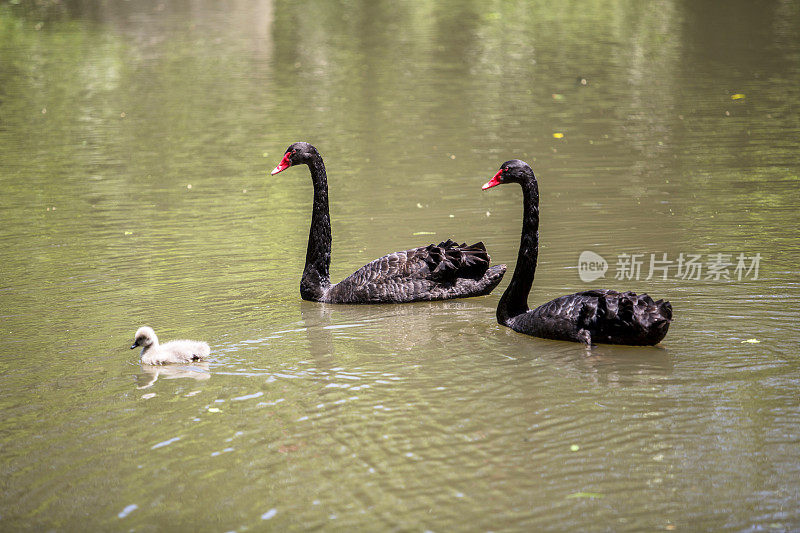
497, 177, 539, 324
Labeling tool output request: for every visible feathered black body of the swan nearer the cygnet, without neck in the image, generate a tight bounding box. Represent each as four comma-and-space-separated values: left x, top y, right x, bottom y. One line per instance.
325, 240, 505, 303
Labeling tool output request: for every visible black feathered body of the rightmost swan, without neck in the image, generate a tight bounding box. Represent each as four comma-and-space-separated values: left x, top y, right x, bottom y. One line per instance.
510, 289, 672, 345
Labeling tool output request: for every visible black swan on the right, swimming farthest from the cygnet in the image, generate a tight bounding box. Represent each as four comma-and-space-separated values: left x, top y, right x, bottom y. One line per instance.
483, 159, 672, 346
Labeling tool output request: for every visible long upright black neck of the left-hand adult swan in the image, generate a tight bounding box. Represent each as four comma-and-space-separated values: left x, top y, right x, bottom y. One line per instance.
300, 155, 331, 301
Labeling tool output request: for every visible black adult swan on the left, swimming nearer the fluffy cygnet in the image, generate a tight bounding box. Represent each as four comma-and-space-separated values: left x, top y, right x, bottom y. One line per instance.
272, 142, 506, 304
